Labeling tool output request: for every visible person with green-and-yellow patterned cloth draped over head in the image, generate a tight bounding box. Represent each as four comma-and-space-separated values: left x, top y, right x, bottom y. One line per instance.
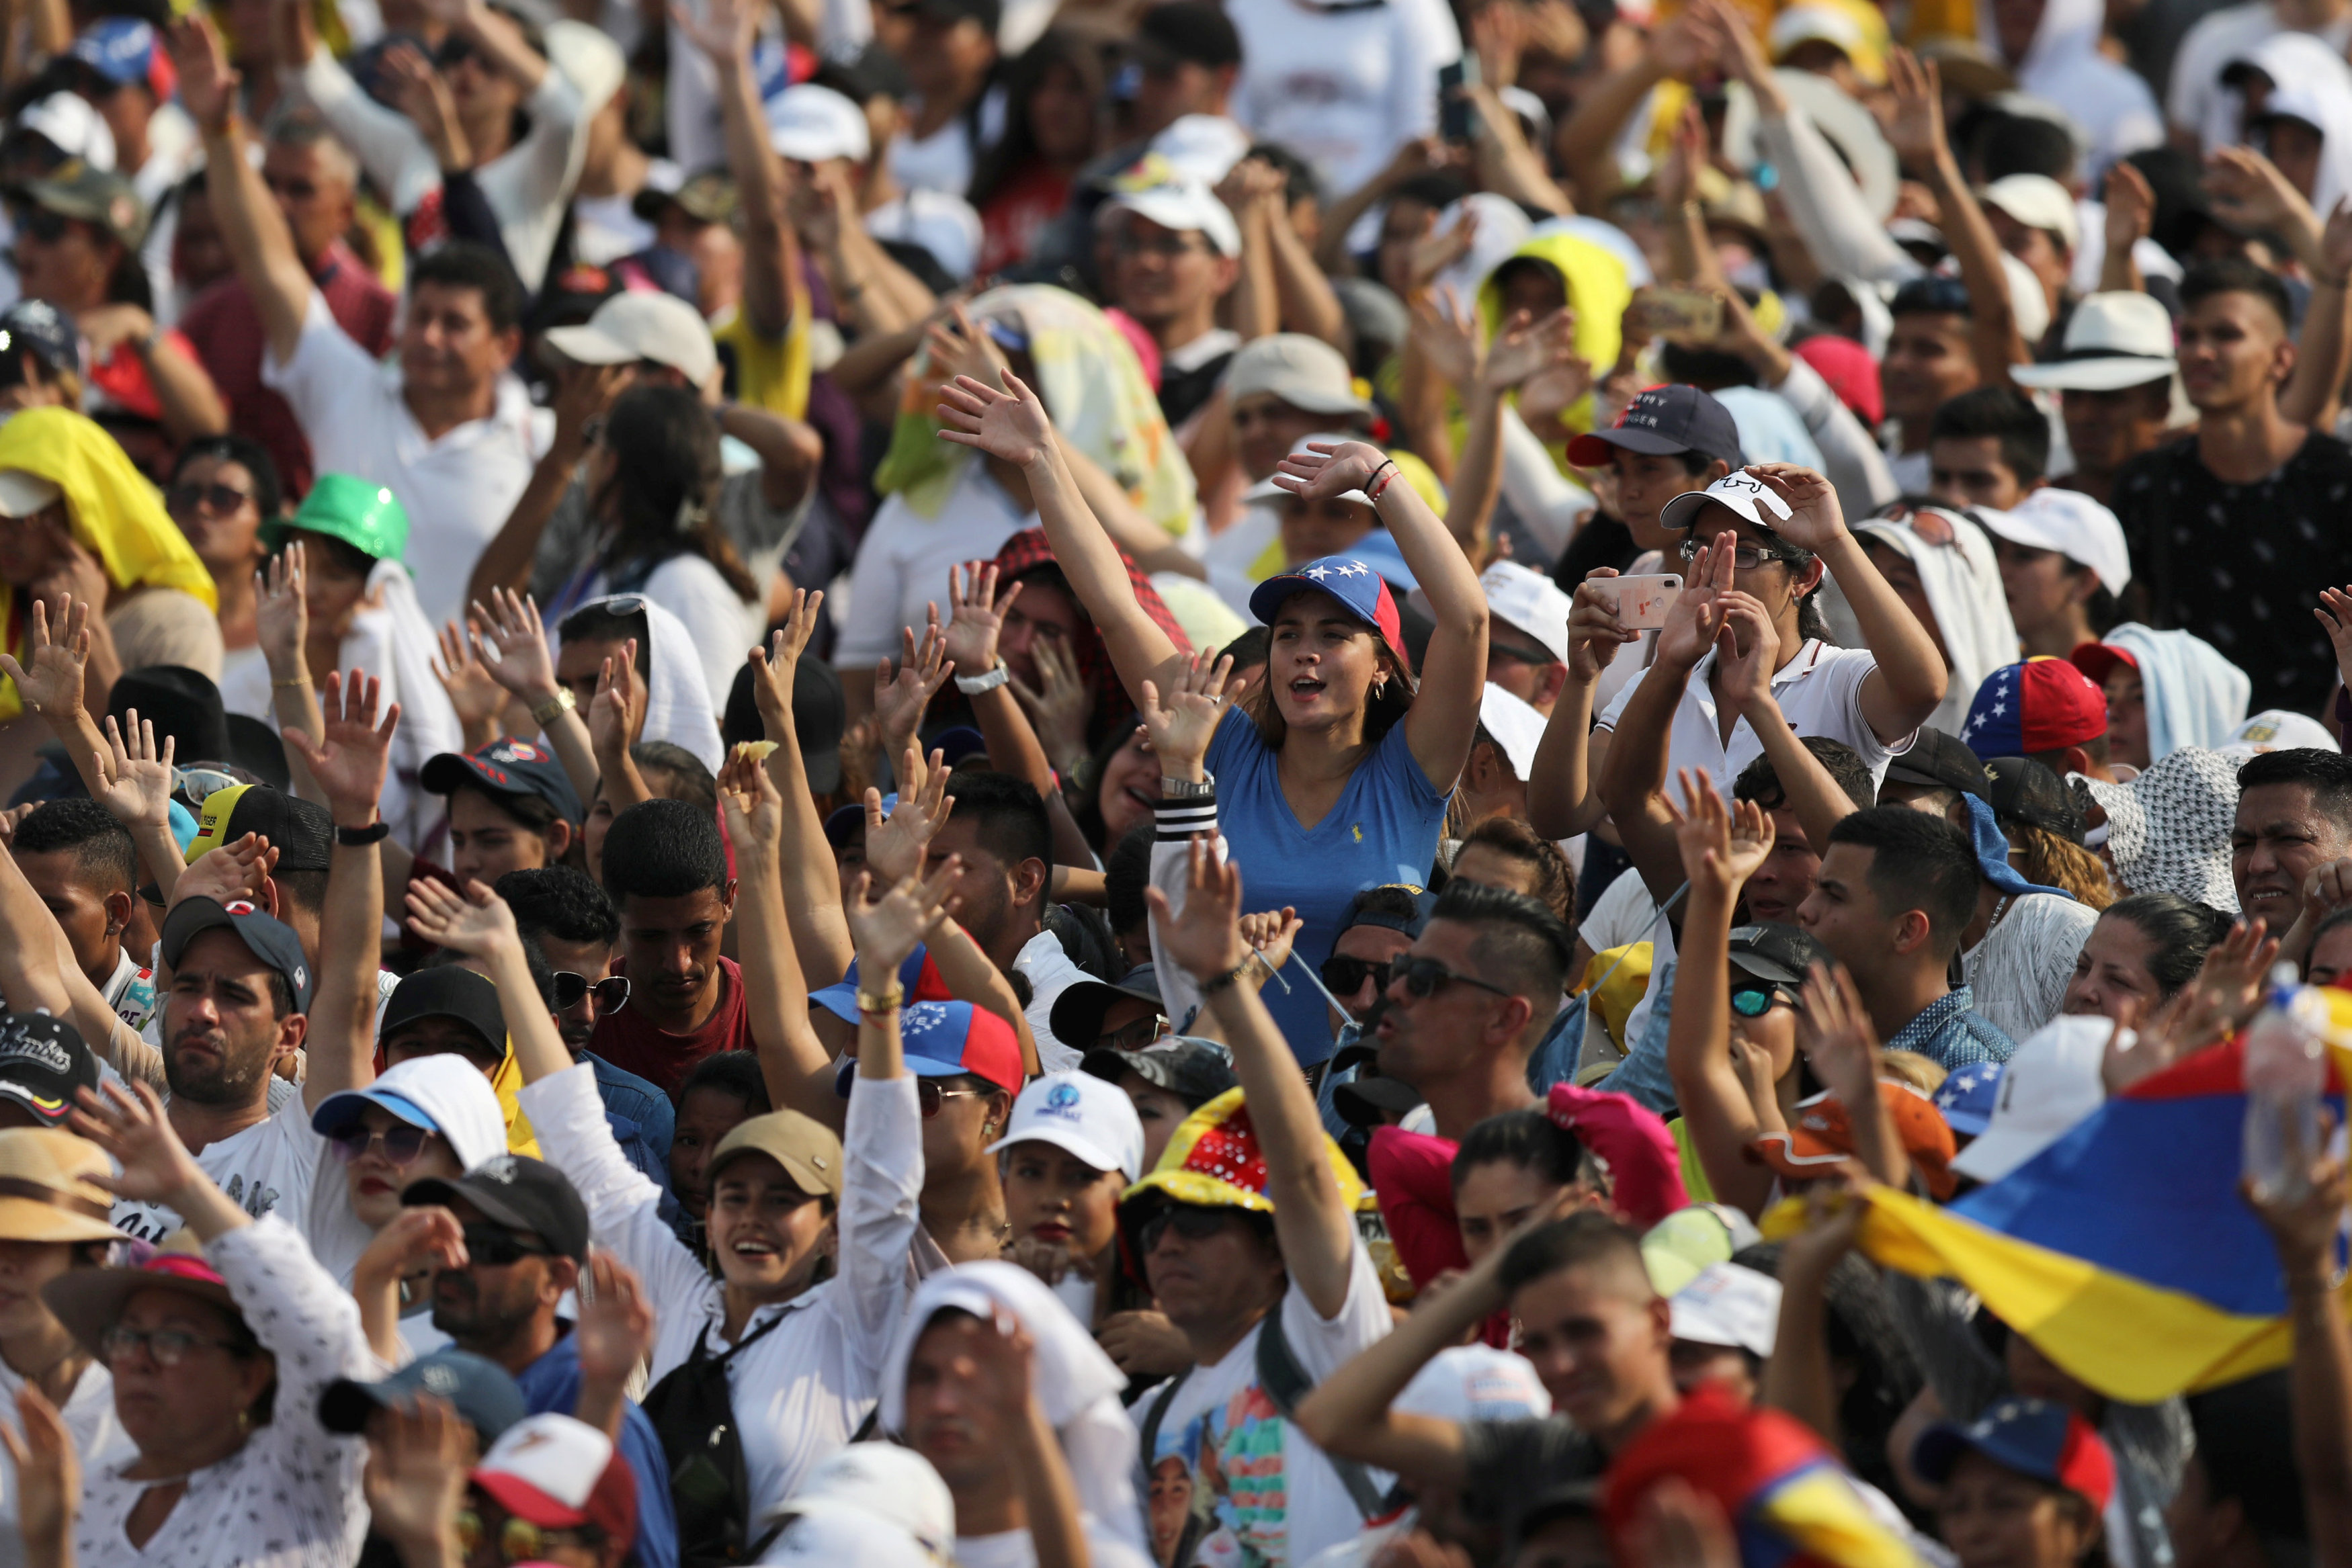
833, 284, 1195, 712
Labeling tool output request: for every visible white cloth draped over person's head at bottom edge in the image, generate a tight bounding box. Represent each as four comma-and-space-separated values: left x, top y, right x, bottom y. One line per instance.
882, 1262, 1148, 1552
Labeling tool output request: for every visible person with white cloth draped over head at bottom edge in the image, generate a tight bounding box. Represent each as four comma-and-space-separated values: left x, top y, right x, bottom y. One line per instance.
880, 1262, 1148, 1568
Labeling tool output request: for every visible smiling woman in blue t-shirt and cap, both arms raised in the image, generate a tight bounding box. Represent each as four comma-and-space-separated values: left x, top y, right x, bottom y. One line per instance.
939, 376, 1486, 1065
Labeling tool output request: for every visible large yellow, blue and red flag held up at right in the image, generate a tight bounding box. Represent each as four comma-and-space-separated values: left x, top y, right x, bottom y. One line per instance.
1764, 992, 2352, 1403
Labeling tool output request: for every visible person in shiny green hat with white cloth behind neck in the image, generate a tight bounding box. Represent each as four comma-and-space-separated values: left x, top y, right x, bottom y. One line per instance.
261, 472, 466, 853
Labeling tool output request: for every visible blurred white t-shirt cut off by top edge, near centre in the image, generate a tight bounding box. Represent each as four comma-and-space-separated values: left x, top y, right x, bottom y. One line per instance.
1226, 0, 1463, 200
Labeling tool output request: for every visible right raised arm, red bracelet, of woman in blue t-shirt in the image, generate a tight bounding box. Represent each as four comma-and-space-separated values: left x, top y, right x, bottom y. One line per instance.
1275, 442, 1486, 792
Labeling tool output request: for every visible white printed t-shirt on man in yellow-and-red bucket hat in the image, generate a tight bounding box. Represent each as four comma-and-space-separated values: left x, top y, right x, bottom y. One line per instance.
1129, 1242, 1390, 1568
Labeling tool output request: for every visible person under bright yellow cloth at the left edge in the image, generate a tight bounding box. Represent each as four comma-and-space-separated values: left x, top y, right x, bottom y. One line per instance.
0, 409, 221, 738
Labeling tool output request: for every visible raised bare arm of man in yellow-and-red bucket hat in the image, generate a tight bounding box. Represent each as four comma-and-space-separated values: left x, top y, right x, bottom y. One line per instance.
1143, 841, 1355, 1321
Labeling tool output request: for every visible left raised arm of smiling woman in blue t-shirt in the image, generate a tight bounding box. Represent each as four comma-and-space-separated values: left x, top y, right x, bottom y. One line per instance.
939, 372, 1185, 705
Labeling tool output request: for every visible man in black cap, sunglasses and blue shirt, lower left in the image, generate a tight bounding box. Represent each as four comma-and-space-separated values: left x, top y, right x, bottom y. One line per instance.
400, 1154, 677, 1568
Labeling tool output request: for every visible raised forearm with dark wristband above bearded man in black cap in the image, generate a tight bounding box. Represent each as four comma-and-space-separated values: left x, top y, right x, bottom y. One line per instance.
287, 670, 397, 1110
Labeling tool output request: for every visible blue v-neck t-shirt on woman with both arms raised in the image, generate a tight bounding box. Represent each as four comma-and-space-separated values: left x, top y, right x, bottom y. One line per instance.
1207, 707, 1454, 1068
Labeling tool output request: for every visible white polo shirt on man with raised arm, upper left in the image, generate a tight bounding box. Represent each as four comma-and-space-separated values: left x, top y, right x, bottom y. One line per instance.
261, 289, 553, 625
